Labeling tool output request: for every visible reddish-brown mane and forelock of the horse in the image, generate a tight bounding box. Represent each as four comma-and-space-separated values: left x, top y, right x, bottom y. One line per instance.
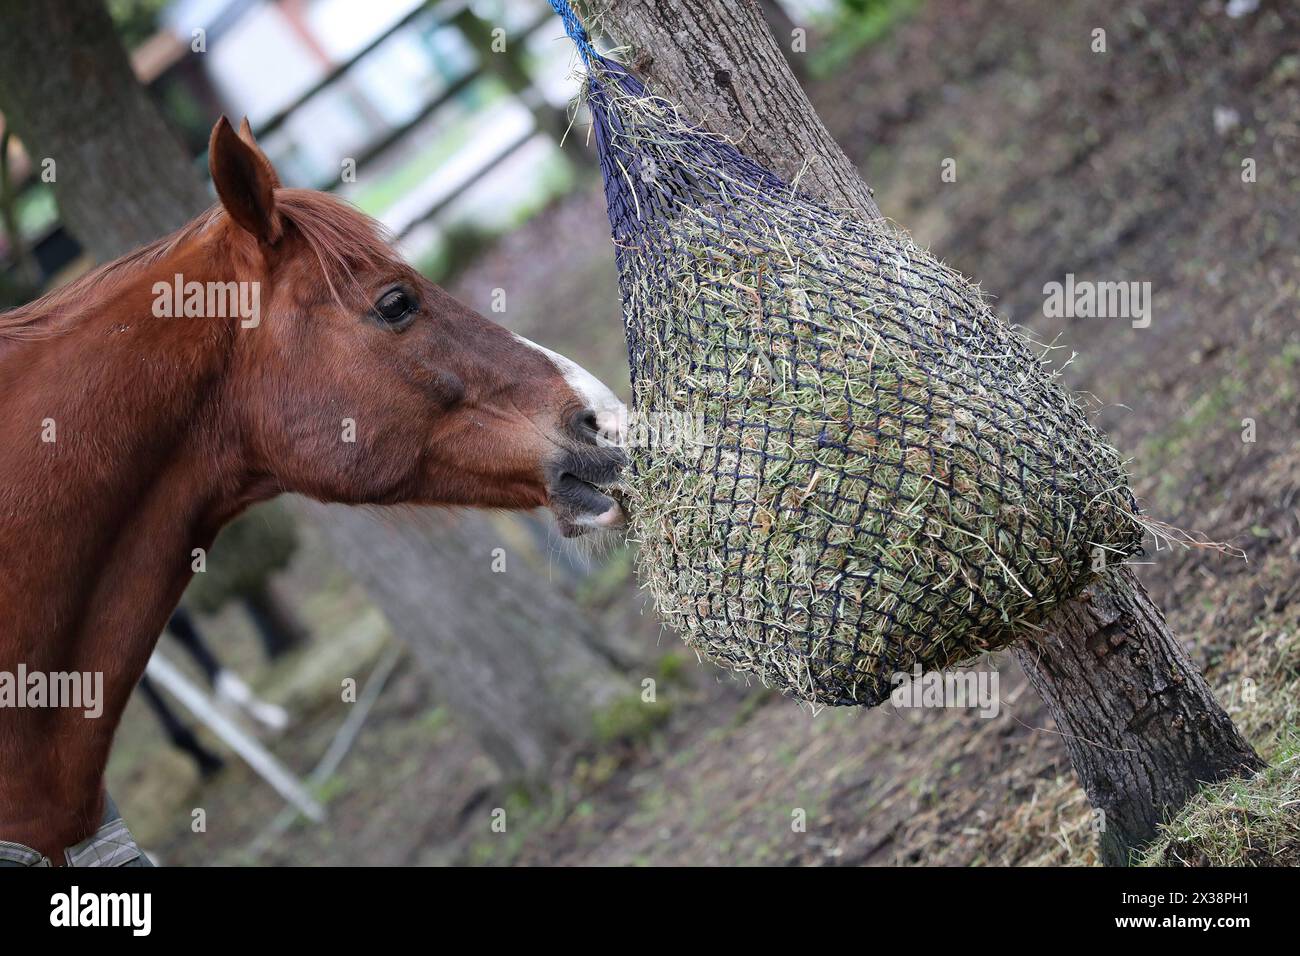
0, 189, 410, 342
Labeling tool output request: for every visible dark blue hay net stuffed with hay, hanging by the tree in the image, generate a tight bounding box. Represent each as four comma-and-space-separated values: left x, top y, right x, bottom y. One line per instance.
551, 0, 1141, 705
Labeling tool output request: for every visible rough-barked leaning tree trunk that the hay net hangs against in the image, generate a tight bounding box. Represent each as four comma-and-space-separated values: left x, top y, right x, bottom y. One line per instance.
581, 0, 1262, 864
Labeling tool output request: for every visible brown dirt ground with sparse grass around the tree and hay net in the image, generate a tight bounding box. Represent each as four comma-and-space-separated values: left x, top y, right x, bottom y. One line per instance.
111, 0, 1300, 865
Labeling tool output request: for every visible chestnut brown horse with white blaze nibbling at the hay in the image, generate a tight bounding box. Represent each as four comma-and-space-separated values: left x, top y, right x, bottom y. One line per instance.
0, 117, 624, 862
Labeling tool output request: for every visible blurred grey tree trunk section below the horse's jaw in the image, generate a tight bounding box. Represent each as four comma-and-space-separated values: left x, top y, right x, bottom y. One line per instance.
298, 499, 631, 778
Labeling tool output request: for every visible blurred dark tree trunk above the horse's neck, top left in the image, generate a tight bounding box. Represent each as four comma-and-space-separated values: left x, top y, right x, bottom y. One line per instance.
0, 0, 212, 261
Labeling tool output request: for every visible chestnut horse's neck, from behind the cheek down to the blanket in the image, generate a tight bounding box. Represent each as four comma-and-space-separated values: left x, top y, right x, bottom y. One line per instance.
0, 234, 250, 858
